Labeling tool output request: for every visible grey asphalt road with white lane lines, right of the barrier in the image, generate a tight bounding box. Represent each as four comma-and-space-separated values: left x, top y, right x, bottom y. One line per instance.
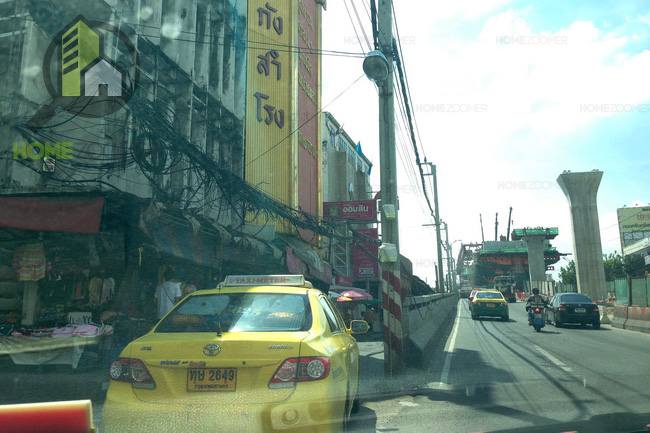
352, 299, 650, 433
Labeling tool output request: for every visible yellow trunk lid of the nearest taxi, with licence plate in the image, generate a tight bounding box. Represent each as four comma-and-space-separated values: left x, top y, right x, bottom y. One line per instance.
127, 332, 308, 405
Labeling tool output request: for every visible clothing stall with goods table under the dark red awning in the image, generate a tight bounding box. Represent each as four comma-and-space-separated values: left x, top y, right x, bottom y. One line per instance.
0, 196, 119, 368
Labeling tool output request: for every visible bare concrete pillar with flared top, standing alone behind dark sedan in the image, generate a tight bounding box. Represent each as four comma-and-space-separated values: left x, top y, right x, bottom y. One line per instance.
557, 170, 606, 300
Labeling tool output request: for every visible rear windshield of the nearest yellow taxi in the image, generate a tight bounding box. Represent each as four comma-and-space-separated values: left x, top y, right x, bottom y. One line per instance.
154, 293, 312, 333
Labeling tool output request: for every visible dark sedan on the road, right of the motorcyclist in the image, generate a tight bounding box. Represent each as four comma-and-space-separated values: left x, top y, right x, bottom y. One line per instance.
546, 293, 600, 329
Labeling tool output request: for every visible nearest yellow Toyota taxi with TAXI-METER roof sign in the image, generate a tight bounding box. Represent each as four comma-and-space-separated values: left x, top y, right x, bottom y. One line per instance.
103, 275, 368, 433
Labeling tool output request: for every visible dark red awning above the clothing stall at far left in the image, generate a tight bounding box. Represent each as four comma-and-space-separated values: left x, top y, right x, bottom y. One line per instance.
0, 197, 104, 233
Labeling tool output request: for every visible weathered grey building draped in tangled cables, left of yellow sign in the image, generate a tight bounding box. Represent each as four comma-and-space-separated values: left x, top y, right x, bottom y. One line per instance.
0, 0, 287, 332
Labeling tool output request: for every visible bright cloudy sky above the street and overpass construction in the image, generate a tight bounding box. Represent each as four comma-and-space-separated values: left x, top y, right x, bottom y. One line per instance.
322, 0, 650, 284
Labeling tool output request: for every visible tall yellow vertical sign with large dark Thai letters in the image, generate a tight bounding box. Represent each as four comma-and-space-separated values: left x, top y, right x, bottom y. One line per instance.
245, 0, 295, 232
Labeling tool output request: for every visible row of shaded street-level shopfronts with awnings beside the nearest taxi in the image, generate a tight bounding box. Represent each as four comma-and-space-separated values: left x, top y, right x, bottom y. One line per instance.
0, 193, 286, 368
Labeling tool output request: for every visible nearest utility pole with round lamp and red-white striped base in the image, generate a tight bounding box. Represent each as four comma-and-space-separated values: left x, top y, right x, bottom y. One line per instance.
364, 0, 408, 377
